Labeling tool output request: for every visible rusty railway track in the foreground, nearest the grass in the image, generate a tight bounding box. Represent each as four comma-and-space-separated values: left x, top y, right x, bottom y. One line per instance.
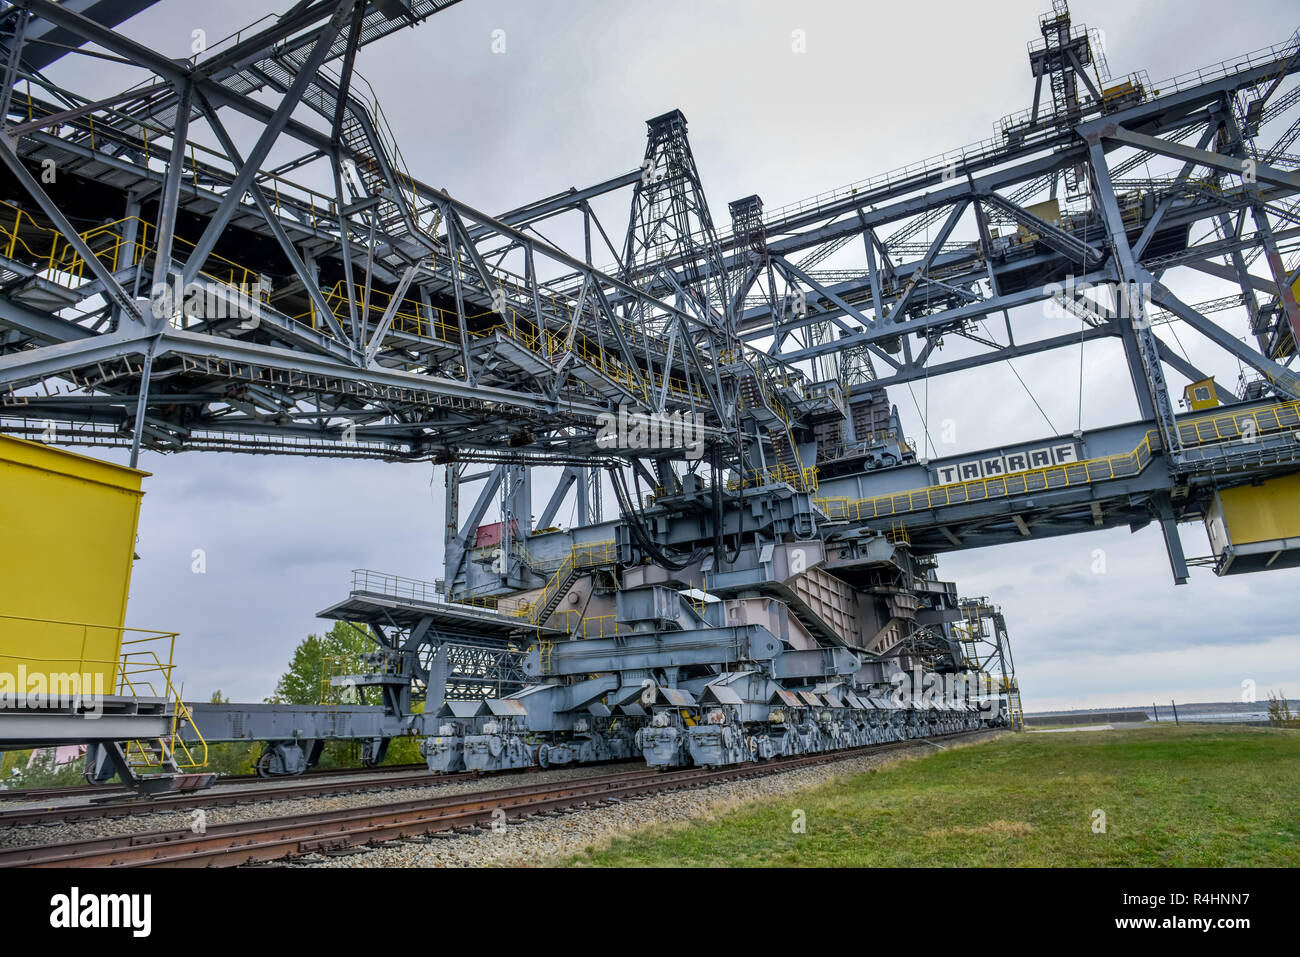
0, 732, 979, 867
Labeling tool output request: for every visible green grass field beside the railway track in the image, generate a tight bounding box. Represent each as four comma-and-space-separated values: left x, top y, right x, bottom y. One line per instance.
569, 726, 1300, 867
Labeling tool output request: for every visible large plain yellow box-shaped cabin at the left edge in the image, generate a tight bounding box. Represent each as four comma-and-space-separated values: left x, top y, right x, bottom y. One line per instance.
0, 434, 148, 694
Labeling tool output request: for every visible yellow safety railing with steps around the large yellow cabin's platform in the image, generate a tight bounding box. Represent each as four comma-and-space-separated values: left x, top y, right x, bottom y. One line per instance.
0, 615, 208, 768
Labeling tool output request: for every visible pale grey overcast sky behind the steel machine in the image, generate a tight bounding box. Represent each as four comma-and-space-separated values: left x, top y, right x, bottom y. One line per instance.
56, 0, 1300, 710
